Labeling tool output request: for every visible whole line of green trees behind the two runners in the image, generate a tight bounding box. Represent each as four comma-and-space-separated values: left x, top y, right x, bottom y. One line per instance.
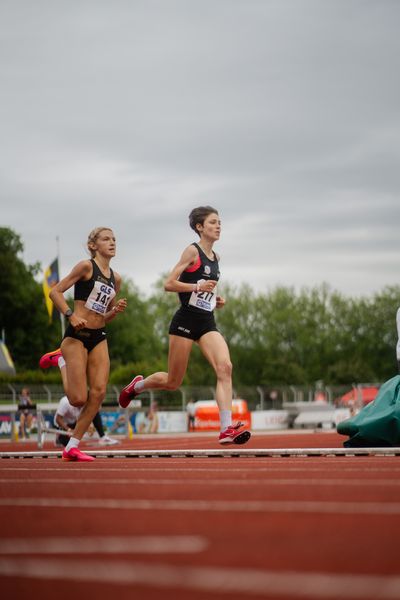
0, 227, 400, 386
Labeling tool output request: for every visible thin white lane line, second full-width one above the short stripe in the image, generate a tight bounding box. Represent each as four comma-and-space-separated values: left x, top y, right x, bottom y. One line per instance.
0, 477, 400, 487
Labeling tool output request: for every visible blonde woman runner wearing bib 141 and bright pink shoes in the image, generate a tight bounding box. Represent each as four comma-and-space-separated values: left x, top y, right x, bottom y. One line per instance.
42, 227, 126, 461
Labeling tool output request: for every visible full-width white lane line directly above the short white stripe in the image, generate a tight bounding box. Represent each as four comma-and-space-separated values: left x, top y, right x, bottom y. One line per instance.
0, 498, 400, 516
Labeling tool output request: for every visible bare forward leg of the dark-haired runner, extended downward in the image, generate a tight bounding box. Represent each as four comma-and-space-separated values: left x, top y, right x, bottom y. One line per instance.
199, 331, 232, 410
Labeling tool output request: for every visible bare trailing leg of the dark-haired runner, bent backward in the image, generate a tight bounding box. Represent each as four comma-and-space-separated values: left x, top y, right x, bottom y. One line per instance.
140, 335, 193, 390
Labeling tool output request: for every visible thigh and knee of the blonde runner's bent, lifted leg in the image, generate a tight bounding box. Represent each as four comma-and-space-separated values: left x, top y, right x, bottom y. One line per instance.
61, 337, 88, 407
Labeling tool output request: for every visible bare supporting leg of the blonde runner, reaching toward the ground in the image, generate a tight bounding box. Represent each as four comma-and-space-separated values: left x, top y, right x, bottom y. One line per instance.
71, 340, 110, 440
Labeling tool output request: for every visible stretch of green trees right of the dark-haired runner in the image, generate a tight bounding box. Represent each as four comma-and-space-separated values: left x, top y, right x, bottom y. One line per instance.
217, 284, 400, 386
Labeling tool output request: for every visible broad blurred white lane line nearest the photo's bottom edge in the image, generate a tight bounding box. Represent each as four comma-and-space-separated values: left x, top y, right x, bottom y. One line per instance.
0, 558, 400, 600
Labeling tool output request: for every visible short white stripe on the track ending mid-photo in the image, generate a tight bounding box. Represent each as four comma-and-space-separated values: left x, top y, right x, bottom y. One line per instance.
0, 535, 208, 555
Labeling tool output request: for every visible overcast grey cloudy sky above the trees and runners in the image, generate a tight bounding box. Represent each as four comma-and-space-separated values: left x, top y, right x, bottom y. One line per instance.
0, 0, 400, 295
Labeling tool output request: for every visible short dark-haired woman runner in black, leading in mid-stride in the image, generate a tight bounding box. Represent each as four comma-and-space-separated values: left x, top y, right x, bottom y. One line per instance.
119, 206, 250, 444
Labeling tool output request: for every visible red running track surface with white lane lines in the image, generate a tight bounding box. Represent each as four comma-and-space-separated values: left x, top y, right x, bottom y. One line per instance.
0, 432, 400, 600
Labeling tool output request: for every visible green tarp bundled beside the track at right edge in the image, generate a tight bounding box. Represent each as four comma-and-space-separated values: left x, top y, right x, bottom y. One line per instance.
337, 375, 400, 448
